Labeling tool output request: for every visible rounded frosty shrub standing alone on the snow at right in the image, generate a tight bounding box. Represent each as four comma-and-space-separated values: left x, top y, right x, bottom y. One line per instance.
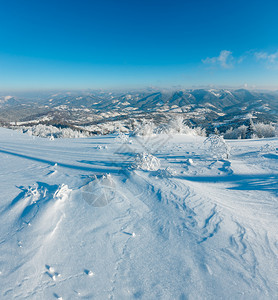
204, 134, 230, 159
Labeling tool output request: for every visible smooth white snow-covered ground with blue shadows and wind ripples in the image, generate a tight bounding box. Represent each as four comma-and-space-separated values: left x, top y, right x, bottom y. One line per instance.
0, 129, 278, 299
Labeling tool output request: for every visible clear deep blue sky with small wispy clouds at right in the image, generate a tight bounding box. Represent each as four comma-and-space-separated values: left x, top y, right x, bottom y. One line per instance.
0, 0, 278, 89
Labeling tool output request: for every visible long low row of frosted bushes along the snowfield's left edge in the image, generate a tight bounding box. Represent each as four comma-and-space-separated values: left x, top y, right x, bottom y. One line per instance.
18, 124, 90, 140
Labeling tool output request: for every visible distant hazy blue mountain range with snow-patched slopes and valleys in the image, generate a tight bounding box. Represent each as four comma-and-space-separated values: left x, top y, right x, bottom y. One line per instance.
0, 89, 278, 131
